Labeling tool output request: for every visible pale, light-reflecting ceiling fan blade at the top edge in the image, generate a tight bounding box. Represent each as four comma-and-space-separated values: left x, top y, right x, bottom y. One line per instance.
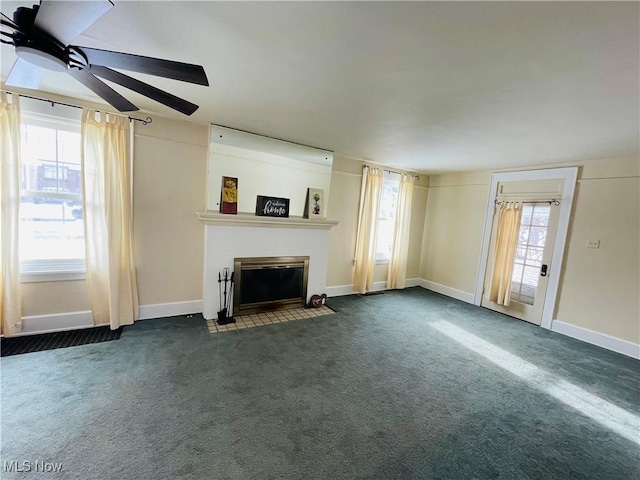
34, 0, 113, 45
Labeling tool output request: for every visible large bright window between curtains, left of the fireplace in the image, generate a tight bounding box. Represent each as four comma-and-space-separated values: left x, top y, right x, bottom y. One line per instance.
19, 99, 85, 280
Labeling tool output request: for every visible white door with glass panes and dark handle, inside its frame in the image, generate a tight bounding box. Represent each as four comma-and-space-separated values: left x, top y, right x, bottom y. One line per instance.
481, 198, 560, 325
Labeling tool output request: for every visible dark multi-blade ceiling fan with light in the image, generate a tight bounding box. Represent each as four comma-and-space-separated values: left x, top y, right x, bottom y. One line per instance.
0, 0, 209, 115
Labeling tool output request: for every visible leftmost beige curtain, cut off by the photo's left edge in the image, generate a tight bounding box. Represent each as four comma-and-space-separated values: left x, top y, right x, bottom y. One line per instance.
0, 92, 22, 336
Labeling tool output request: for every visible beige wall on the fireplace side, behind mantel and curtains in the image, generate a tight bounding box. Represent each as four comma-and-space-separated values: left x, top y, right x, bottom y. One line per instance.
22, 123, 428, 316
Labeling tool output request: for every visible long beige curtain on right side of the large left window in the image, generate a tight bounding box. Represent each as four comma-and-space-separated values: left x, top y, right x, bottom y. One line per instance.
82, 110, 138, 330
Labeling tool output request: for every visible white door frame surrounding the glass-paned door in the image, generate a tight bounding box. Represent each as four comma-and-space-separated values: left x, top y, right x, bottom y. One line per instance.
473, 167, 578, 330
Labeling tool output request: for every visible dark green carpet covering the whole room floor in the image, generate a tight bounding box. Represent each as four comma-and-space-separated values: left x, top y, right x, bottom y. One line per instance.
0, 288, 640, 480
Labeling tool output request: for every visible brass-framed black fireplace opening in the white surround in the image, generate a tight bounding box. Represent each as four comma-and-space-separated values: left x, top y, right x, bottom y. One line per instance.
233, 257, 309, 315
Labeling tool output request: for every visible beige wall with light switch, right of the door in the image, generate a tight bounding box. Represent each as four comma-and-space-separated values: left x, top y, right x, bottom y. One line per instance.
554, 159, 640, 343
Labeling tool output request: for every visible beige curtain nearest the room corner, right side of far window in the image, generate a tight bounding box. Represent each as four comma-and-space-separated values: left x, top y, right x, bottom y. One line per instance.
387, 175, 415, 288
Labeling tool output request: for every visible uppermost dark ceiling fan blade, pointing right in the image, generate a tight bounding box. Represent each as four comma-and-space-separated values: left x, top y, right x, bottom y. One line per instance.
77, 47, 209, 86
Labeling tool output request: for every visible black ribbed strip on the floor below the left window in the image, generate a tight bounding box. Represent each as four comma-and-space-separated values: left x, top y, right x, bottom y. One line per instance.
0, 327, 124, 357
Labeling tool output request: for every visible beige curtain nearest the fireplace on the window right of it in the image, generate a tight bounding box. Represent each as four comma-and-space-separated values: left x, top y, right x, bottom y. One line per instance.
353, 166, 382, 293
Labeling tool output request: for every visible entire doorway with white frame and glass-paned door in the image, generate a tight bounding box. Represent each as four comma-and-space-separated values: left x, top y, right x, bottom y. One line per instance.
474, 167, 577, 328
